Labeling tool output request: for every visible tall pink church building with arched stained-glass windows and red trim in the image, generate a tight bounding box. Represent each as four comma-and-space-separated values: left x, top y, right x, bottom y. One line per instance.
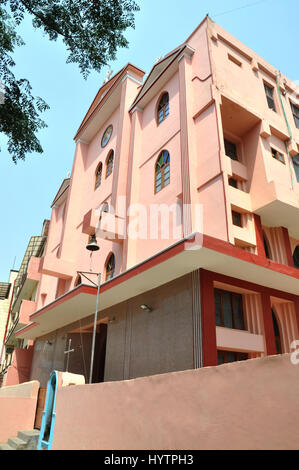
4, 17, 299, 387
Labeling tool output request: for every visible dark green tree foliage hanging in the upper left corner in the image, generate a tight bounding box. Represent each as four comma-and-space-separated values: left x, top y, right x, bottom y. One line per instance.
0, 0, 139, 163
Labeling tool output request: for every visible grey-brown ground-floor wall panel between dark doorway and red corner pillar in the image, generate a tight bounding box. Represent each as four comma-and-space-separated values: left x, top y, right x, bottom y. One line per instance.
105, 276, 193, 381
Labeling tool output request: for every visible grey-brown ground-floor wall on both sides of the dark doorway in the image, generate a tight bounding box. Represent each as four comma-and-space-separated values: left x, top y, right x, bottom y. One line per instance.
31, 275, 194, 387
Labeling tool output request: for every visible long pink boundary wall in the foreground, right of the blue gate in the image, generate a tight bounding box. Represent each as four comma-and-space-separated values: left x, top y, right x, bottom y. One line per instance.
53, 354, 299, 450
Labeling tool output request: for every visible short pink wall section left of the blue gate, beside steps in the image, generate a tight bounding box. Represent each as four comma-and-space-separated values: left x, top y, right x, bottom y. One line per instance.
0, 380, 40, 443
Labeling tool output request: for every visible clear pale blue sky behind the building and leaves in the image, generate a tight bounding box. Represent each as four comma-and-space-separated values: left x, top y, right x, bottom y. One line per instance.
0, 0, 299, 281
